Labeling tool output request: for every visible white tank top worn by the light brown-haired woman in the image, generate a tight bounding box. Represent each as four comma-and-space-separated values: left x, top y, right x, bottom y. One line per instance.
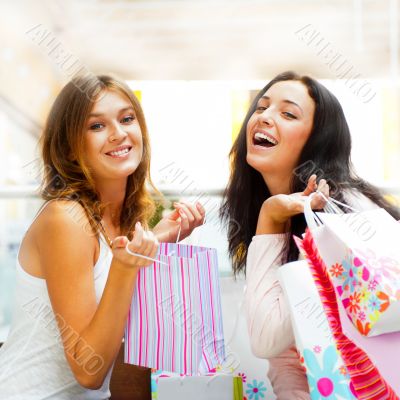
0, 202, 112, 400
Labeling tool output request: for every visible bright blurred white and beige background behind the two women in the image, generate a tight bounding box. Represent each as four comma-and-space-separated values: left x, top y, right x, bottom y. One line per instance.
0, 0, 400, 360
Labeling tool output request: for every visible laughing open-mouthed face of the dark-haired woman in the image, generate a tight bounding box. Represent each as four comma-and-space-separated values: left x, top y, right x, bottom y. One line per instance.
246, 81, 315, 186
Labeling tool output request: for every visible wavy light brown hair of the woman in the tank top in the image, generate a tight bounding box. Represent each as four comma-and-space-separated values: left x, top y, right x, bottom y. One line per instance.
40, 75, 160, 237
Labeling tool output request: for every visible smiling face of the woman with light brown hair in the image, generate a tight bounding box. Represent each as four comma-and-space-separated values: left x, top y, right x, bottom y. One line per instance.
85, 90, 143, 180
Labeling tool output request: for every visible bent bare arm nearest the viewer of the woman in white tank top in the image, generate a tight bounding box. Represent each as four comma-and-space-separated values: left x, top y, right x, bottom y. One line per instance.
37, 201, 158, 389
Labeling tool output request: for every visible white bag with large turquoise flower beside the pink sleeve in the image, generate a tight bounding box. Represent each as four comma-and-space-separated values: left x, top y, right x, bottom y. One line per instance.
278, 261, 356, 400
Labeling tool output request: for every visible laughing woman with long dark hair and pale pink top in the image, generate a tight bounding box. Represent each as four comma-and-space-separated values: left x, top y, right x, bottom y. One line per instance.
221, 72, 400, 400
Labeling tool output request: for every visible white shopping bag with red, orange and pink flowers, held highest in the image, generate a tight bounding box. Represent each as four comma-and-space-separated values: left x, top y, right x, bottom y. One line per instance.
317, 208, 400, 336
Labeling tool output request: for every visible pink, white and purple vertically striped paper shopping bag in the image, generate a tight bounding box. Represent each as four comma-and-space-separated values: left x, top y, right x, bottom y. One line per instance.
125, 243, 225, 375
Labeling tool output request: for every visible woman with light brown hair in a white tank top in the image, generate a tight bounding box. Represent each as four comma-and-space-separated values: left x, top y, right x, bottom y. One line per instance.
0, 76, 204, 399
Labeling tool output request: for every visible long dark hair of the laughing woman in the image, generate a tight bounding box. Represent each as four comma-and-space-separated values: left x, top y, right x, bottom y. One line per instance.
220, 71, 400, 274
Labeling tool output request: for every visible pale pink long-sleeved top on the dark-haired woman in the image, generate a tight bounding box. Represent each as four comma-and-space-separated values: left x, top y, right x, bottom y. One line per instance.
245, 192, 377, 400
